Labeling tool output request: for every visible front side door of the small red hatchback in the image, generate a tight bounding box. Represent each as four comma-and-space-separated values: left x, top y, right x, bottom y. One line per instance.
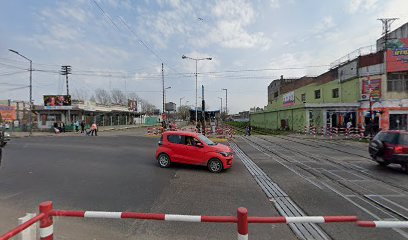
182, 136, 206, 165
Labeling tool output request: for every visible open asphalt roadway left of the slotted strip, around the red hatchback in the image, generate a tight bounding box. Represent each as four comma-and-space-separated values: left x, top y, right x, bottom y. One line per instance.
0, 130, 296, 239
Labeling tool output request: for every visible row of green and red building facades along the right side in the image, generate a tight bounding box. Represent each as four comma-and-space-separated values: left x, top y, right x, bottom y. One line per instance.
250, 24, 408, 131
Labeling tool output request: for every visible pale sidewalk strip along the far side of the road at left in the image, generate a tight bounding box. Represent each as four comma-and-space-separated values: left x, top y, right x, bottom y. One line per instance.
9, 125, 148, 138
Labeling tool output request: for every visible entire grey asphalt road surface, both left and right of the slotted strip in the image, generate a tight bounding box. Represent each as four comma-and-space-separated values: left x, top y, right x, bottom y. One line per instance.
0, 129, 408, 239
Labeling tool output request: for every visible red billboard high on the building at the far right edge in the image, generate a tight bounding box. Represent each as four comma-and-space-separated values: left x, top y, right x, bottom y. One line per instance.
387, 38, 408, 72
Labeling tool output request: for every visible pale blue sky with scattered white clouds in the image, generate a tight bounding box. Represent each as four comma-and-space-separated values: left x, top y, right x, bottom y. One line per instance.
0, 0, 408, 113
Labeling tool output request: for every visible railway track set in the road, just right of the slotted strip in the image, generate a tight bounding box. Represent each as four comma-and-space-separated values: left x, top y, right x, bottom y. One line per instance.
236, 136, 408, 239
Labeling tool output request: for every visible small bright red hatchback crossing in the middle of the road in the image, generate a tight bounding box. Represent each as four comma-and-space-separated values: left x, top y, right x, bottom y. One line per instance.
156, 131, 234, 173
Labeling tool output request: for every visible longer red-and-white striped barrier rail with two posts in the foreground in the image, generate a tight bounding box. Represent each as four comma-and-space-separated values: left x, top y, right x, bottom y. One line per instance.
0, 201, 358, 240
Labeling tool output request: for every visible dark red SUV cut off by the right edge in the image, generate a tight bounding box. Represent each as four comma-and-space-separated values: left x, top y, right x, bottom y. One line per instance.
368, 130, 408, 173
